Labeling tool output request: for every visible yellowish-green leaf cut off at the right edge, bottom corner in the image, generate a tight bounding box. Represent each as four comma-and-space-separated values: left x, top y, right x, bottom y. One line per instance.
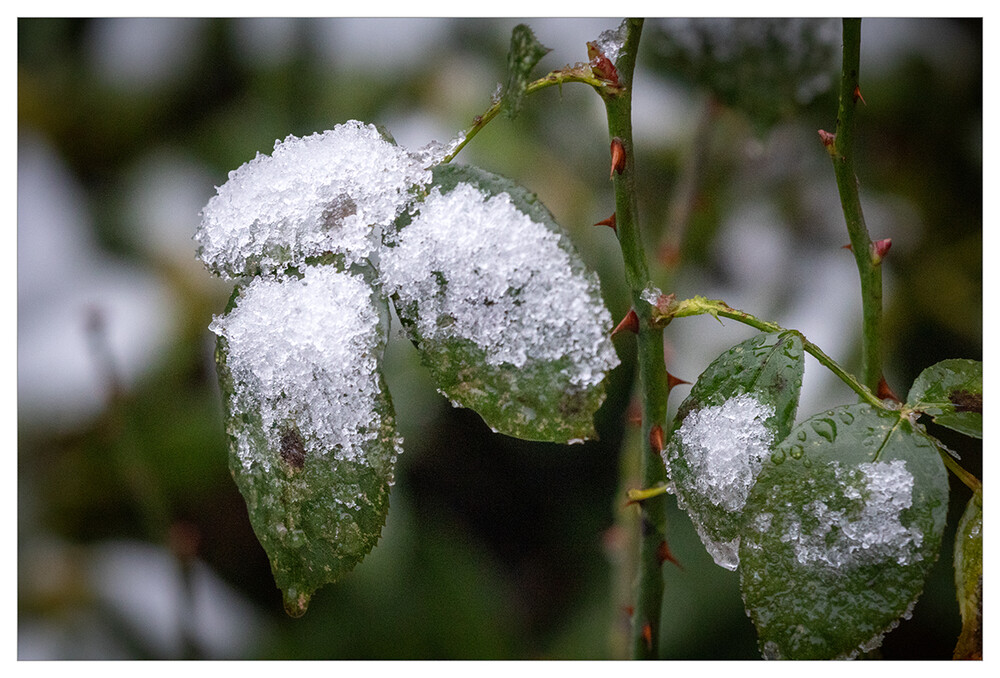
955, 491, 983, 659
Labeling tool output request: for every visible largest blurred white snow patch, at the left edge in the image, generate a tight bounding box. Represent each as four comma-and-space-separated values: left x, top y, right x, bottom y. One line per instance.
17, 136, 174, 430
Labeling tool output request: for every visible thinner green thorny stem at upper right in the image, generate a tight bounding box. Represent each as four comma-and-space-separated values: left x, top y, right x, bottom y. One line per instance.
824, 19, 882, 392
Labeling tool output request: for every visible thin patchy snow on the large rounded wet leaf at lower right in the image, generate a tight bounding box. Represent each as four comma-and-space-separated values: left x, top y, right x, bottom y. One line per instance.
781, 459, 923, 567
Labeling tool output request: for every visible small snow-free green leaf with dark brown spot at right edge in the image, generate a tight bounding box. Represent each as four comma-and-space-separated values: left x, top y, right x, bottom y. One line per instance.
906, 359, 983, 438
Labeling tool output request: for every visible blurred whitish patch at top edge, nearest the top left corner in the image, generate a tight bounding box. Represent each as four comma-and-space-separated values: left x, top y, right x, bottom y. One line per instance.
86, 18, 206, 91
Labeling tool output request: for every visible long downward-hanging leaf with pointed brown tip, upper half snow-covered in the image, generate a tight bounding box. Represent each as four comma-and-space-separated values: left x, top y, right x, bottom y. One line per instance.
210, 267, 401, 616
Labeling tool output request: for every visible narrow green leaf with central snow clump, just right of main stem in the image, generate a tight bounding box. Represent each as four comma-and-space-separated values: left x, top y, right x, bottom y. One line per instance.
663, 332, 803, 570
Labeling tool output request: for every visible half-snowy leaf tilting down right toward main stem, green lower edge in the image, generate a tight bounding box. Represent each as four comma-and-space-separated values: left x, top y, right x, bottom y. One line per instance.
380, 167, 619, 442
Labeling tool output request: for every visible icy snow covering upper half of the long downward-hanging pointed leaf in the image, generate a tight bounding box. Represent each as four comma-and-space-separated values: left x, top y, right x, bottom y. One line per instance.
209, 267, 390, 470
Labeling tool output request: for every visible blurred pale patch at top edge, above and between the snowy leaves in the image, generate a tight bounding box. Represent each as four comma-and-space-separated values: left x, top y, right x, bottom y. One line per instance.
310, 18, 449, 71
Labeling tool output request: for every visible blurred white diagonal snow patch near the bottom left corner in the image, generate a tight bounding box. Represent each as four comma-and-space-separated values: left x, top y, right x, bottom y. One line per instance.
89, 541, 267, 659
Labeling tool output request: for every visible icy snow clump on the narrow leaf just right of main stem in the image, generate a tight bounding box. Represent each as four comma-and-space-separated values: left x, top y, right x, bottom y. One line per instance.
661, 394, 774, 570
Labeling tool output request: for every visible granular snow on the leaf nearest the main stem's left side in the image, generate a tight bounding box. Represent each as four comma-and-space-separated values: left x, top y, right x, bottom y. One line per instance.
380, 183, 619, 389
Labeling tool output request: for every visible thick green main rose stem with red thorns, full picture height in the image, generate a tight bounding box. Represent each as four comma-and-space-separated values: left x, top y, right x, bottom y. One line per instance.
602, 19, 670, 659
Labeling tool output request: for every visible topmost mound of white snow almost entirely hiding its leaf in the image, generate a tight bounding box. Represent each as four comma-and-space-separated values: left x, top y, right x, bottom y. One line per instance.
195, 121, 431, 278
